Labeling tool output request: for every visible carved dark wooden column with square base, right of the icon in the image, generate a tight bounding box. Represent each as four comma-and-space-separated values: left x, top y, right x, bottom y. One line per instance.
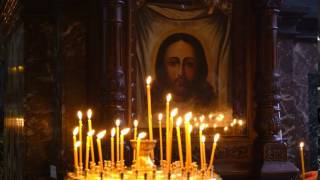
254, 0, 297, 179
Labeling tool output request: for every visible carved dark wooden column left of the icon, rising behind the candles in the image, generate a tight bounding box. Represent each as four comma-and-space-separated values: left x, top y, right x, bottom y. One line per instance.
102, 0, 128, 127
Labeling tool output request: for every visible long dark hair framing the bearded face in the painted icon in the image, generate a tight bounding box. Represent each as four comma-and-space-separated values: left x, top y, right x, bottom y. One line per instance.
155, 33, 208, 85
